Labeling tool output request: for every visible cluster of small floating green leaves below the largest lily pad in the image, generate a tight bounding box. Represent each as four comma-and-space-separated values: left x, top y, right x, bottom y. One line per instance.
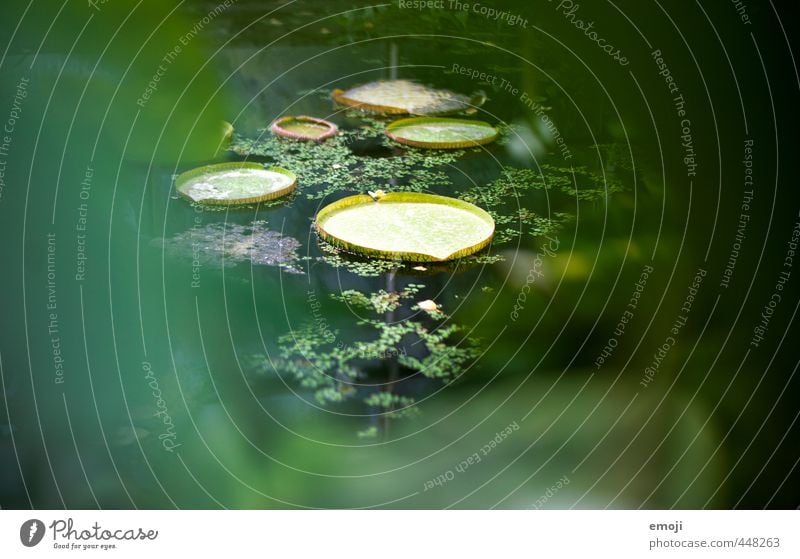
277, 284, 479, 422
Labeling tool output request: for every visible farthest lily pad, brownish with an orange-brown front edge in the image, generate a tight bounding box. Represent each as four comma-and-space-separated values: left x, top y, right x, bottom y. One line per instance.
331, 80, 485, 115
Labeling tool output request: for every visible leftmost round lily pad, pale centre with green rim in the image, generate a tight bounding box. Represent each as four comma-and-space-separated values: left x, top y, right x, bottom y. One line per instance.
175, 162, 297, 205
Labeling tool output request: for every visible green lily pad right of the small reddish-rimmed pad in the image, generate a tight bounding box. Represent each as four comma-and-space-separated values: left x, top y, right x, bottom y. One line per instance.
386, 117, 498, 149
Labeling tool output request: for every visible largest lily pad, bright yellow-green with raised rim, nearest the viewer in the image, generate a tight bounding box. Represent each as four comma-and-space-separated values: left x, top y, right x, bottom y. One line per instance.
316, 192, 494, 262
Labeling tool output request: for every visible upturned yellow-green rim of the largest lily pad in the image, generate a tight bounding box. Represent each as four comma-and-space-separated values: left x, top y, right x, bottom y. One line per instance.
314, 192, 495, 262
